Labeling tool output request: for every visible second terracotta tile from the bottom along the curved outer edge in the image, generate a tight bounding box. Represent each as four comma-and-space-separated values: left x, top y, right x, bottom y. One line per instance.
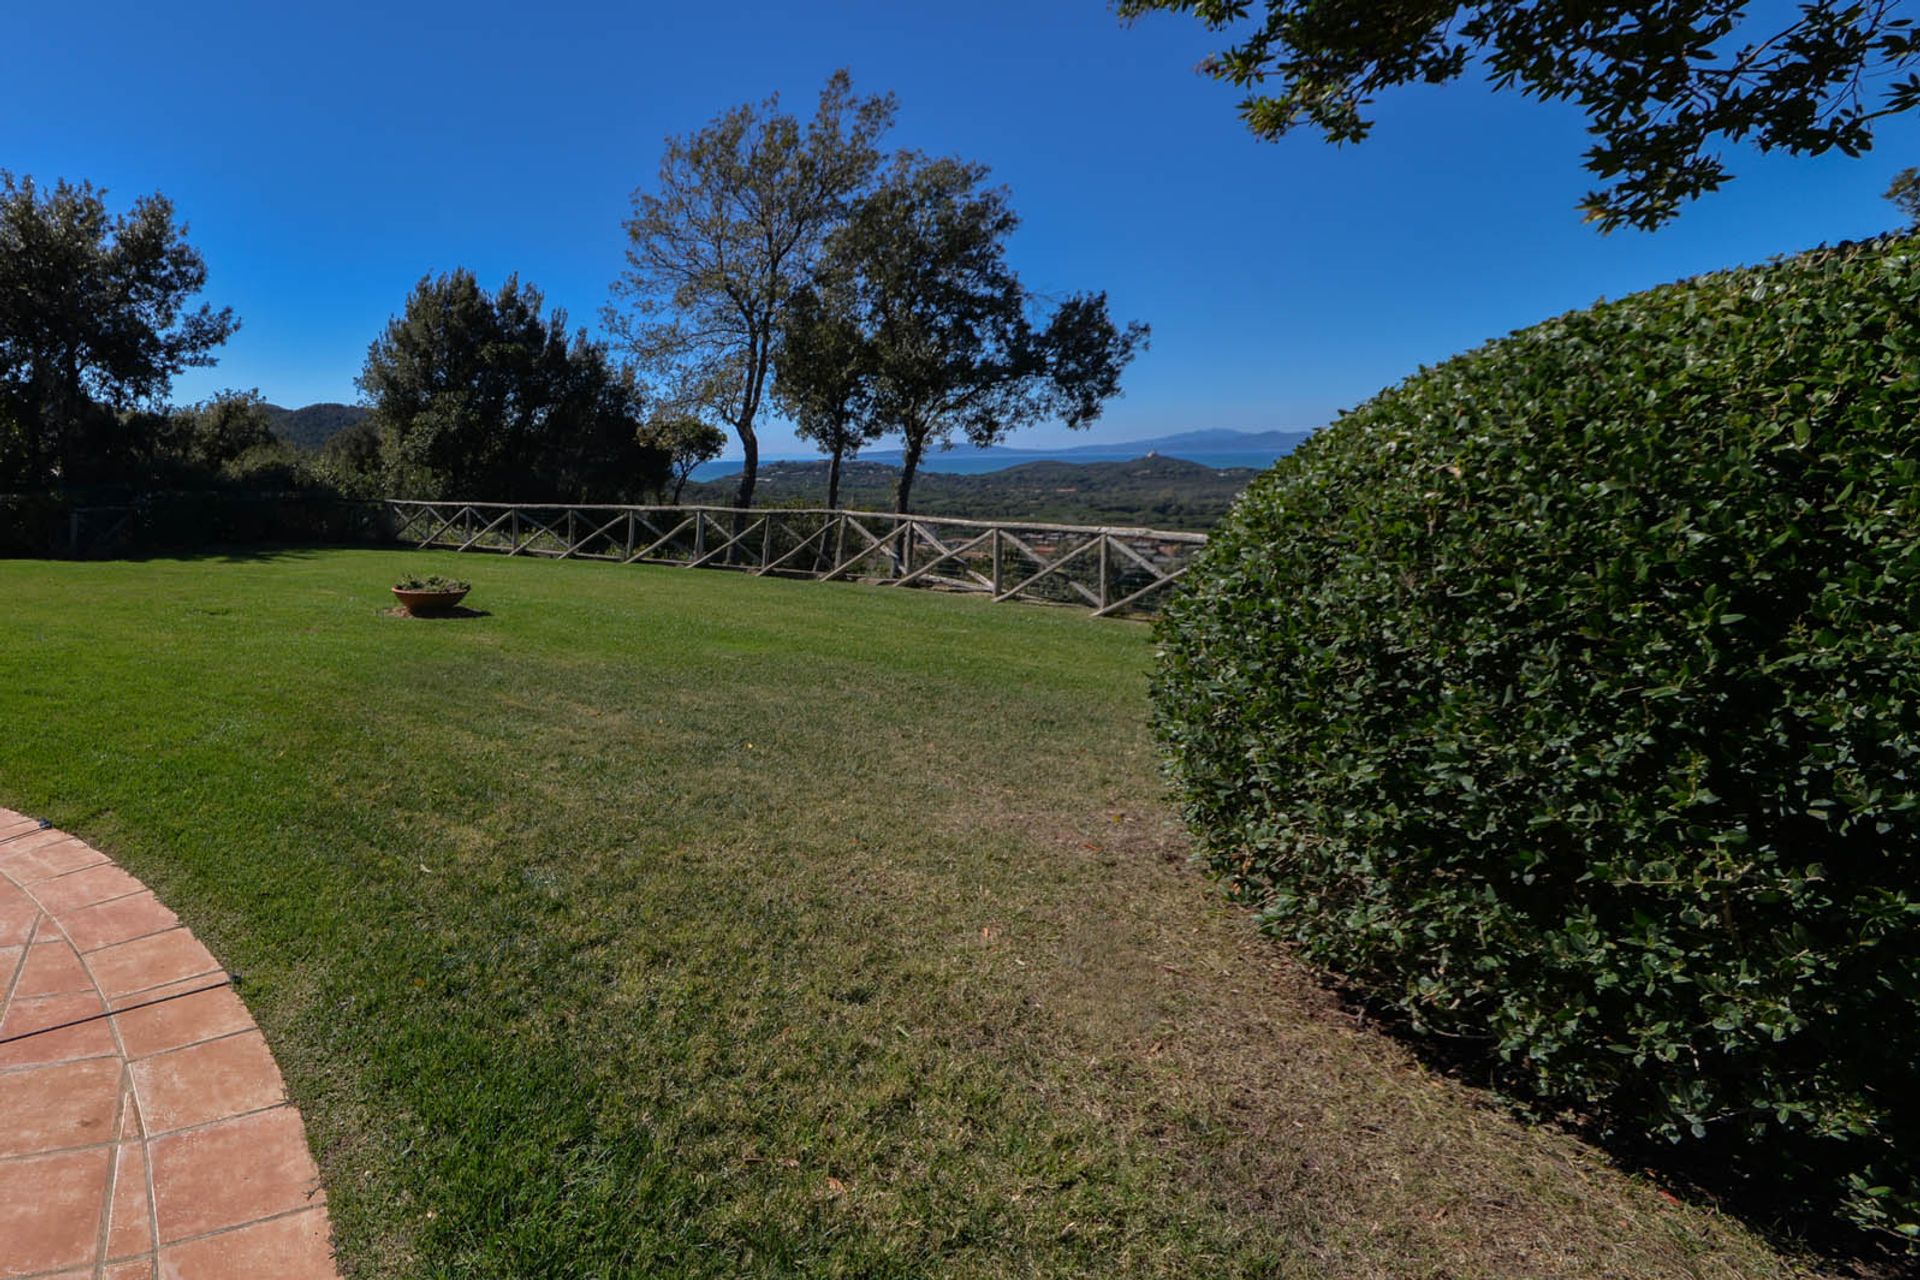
148, 1107, 321, 1242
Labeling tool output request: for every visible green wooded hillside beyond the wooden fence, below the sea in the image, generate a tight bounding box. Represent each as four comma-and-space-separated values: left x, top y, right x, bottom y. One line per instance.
682, 457, 1260, 530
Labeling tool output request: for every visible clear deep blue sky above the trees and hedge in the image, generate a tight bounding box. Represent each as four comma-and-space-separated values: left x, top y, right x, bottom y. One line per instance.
0, 0, 1920, 455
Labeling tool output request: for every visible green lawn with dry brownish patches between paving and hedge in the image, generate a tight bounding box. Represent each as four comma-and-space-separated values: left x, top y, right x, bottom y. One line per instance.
0, 551, 1812, 1278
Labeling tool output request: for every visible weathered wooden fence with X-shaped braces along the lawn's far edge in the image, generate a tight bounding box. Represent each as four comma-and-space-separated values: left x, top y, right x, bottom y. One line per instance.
386, 499, 1206, 618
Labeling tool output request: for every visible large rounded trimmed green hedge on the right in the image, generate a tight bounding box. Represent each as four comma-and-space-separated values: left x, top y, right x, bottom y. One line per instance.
1156, 240, 1920, 1238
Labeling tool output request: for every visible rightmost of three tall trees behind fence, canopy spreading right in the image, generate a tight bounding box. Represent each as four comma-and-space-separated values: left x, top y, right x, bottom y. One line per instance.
831, 155, 1146, 510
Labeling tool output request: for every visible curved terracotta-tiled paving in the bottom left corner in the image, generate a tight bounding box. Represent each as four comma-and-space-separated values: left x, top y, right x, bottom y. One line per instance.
0, 808, 338, 1280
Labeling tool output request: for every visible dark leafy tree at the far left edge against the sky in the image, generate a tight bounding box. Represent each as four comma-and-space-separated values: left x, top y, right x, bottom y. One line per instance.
0, 169, 240, 487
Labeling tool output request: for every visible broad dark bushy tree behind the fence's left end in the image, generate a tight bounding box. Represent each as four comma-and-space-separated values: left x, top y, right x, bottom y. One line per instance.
359, 271, 664, 501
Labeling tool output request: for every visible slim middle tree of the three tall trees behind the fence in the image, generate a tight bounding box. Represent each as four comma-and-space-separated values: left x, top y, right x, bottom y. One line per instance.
774, 265, 881, 507
